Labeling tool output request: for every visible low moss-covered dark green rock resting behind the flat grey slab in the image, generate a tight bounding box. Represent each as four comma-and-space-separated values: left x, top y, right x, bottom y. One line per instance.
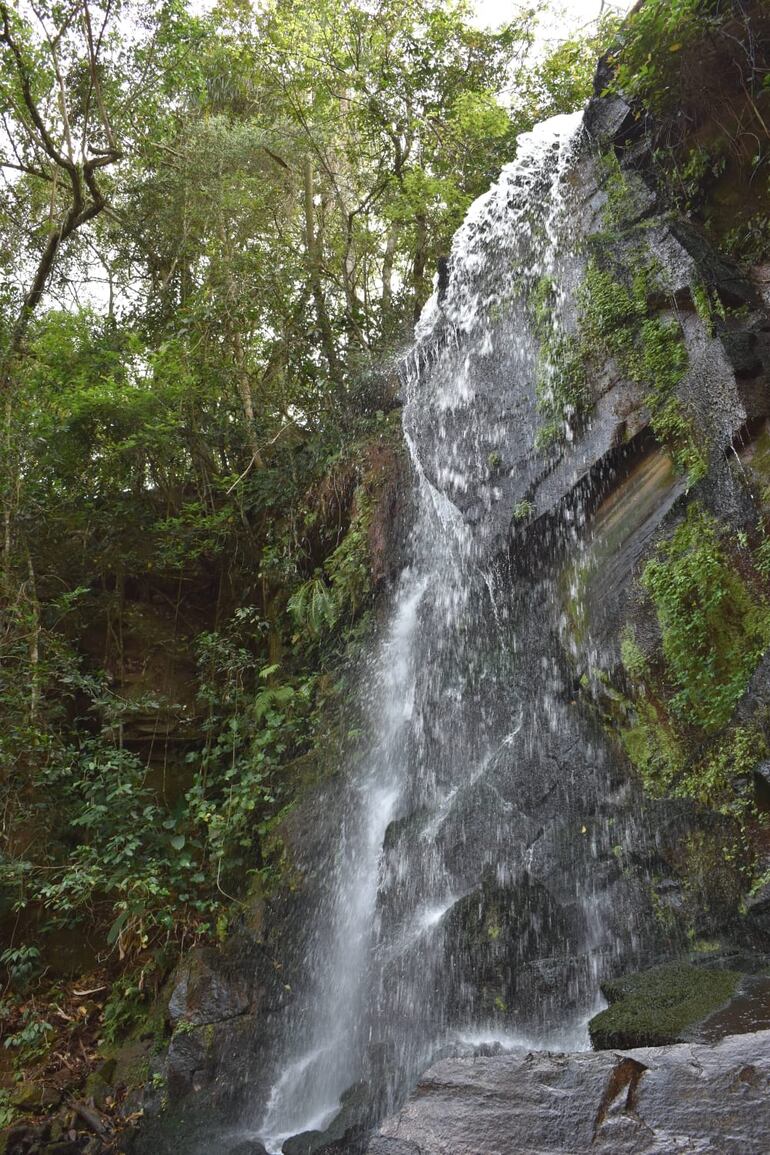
589, 962, 743, 1051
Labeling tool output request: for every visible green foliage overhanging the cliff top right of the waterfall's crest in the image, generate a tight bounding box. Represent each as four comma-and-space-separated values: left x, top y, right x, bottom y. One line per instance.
610, 0, 770, 270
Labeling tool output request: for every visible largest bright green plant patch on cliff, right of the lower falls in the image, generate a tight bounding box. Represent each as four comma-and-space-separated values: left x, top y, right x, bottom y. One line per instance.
606, 505, 770, 873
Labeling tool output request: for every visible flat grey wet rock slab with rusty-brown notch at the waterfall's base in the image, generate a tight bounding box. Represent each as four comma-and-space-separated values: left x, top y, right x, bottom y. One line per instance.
367, 1031, 770, 1155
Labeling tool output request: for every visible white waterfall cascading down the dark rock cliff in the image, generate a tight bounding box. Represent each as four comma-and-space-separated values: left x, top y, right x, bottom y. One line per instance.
254, 116, 655, 1150
